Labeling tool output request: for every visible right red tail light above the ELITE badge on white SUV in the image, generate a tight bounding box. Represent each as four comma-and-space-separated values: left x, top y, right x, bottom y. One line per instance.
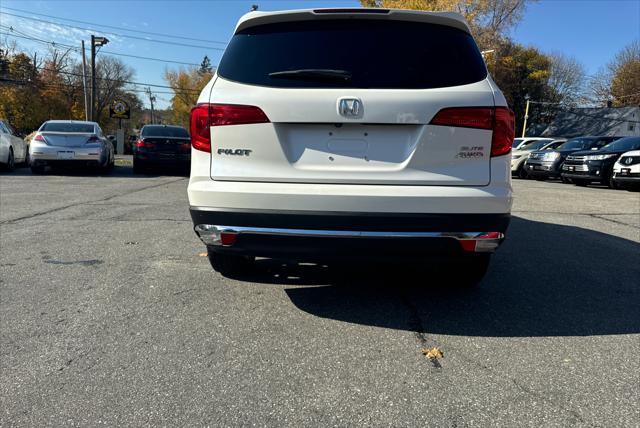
430, 107, 515, 156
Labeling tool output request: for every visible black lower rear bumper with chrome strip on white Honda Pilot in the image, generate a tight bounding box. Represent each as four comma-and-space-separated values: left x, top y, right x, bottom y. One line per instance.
190, 207, 510, 260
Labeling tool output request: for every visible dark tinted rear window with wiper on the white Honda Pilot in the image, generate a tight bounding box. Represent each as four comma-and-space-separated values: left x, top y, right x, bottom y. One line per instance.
218, 19, 487, 89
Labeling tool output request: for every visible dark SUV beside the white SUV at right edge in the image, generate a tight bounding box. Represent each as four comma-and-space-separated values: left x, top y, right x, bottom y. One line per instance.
562, 137, 640, 189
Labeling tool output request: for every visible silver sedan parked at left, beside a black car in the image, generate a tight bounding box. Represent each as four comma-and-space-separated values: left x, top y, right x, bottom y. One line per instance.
29, 120, 114, 173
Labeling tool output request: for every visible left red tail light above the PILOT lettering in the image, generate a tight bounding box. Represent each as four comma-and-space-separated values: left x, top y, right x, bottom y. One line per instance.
189, 104, 269, 152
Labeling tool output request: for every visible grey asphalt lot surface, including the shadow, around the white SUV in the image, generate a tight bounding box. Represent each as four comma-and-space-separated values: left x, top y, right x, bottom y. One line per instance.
0, 166, 640, 427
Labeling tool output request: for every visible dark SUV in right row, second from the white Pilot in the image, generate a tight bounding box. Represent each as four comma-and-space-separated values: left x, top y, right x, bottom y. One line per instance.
524, 136, 620, 181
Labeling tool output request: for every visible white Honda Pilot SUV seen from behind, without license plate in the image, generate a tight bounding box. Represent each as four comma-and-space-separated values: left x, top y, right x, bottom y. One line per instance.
188, 9, 514, 283
